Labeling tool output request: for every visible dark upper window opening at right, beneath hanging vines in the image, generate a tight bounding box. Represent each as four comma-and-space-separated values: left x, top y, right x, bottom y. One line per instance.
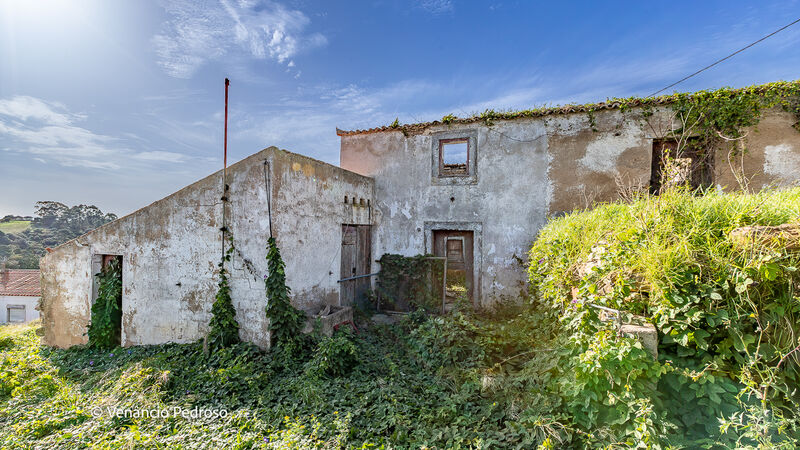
650, 138, 714, 195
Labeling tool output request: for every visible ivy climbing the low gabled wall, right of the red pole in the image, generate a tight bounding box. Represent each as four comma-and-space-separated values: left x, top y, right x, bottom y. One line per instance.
264, 237, 305, 353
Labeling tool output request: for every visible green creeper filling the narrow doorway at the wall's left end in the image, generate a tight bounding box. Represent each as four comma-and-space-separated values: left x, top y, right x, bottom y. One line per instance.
87, 258, 122, 349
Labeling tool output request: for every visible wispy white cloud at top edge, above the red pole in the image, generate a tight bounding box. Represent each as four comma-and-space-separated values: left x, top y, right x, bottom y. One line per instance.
153, 0, 327, 78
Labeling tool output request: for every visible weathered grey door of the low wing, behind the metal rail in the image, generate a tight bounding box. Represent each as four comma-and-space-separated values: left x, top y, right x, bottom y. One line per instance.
339, 225, 372, 308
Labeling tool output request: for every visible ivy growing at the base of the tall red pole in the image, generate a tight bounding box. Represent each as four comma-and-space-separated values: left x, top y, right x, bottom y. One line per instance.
207, 237, 239, 351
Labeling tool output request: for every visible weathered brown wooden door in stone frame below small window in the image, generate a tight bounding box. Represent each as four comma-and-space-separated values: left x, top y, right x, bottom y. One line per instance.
433, 230, 475, 313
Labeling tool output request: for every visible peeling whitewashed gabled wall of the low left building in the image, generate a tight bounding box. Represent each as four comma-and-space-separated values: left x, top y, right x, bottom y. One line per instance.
40, 147, 373, 347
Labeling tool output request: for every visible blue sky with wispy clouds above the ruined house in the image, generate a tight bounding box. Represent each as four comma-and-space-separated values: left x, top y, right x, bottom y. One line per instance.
0, 0, 800, 216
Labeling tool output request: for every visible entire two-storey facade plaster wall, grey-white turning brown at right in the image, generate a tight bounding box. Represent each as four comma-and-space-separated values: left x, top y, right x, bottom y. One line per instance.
340, 108, 800, 304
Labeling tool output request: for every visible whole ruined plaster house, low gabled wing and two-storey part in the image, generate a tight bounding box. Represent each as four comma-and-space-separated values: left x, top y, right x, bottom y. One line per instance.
41, 82, 800, 347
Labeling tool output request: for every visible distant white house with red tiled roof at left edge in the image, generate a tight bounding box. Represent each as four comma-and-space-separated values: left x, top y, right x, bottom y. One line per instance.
0, 269, 42, 324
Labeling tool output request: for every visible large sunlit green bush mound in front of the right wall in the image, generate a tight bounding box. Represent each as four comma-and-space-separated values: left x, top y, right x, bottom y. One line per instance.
529, 189, 800, 448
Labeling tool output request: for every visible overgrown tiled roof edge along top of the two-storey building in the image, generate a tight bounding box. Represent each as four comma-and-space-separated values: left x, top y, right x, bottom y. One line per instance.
336, 80, 800, 136
